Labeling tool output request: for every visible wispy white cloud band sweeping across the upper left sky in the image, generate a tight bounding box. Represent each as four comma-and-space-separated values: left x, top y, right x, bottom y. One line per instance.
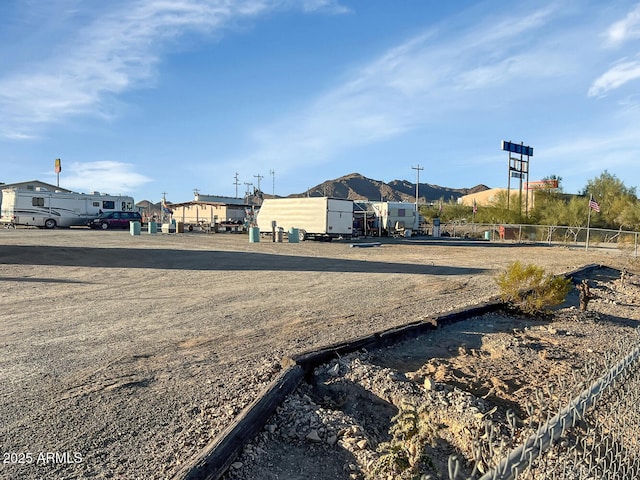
0, 0, 347, 139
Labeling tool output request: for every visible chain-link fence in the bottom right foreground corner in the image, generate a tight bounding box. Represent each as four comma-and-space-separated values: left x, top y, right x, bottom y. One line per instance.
449, 332, 640, 480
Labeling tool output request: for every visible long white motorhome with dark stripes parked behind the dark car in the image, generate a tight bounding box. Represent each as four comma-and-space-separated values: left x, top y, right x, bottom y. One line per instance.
0, 187, 135, 228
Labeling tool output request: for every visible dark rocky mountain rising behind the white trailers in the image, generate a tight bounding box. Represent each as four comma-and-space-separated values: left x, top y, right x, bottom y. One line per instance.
289, 173, 489, 203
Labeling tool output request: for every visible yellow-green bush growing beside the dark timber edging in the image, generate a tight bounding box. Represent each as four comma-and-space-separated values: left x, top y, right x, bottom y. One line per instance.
496, 262, 571, 315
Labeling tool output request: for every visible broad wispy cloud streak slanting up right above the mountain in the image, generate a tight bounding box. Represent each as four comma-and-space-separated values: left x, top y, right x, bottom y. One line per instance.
229, 3, 566, 176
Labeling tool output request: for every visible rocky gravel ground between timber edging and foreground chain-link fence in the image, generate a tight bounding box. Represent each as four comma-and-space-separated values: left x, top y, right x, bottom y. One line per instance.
224, 269, 640, 480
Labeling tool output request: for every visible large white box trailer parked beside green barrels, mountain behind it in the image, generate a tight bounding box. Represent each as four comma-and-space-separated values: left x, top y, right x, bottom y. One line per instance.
256, 197, 353, 241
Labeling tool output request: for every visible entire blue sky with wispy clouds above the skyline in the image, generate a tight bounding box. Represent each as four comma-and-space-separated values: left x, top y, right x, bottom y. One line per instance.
0, 0, 640, 202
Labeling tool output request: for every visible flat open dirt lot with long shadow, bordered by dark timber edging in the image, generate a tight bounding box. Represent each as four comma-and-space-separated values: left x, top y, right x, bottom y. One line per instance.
0, 229, 637, 479
